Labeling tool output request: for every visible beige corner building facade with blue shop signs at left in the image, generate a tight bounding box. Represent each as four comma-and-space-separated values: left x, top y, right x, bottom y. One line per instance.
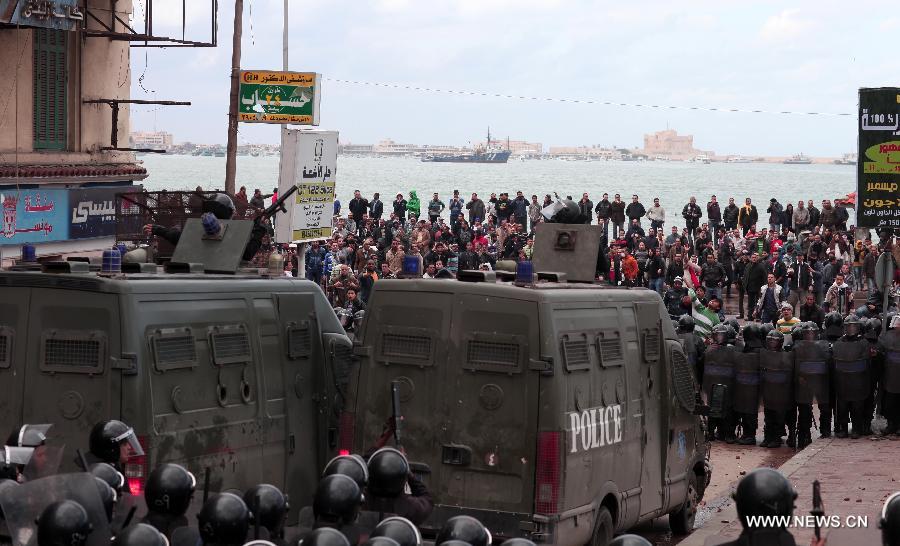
0, 0, 147, 259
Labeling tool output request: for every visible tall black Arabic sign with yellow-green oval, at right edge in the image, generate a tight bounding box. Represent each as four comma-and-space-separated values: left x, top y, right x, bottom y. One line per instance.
856, 87, 900, 228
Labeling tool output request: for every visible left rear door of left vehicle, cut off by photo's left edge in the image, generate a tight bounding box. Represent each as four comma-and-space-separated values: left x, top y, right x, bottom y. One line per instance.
0, 287, 31, 433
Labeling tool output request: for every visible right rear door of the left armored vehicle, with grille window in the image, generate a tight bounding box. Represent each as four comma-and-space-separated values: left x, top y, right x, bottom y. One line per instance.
22, 288, 122, 467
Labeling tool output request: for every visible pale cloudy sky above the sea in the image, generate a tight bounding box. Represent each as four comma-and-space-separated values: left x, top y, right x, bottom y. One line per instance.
131, 0, 900, 156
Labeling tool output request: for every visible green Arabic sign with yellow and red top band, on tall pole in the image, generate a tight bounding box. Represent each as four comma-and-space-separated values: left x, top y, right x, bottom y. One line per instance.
238, 70, 321, 125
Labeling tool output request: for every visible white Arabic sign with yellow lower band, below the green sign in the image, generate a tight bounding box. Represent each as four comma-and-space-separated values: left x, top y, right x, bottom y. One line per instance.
275, 130, 338, 243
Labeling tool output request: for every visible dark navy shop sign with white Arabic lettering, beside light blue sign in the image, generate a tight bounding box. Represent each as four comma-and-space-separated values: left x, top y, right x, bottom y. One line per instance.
69, 186, 141, 239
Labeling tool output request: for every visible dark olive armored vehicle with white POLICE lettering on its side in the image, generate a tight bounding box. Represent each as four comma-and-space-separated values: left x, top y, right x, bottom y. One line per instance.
344, 224, 710, 545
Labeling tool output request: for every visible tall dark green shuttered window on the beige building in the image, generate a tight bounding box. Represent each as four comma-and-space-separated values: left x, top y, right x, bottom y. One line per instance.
33, 28, 68, 150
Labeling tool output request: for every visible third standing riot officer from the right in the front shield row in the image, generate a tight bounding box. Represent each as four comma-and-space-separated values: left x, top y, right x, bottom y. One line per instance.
791, 322, 832, 449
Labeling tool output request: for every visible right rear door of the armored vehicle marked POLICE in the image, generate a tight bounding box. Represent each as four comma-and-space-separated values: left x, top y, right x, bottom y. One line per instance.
433, 294, 542, 514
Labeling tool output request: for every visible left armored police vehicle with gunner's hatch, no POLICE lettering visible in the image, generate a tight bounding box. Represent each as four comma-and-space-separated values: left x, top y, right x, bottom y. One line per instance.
0, 214, 352, 521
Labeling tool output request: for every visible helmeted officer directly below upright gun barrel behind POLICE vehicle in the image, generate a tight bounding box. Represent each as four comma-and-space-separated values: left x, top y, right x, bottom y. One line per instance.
366, 447, 434, 525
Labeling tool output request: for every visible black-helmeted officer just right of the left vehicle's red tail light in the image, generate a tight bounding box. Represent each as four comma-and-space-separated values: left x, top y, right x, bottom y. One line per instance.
143, 463, 197, 539
